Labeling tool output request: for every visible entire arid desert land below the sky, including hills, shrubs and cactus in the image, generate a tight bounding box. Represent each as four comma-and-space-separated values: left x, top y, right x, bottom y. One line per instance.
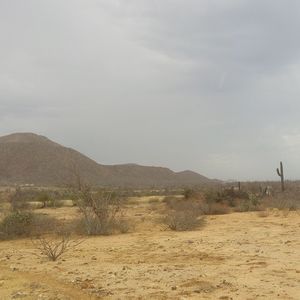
0, 133, 300, 300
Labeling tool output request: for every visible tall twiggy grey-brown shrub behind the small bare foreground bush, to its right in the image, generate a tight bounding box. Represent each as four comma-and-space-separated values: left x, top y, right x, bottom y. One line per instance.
76, 187, 126, 235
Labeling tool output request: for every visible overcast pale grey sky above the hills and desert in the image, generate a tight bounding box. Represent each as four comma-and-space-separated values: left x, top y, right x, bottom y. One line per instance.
0, 0, 300, 180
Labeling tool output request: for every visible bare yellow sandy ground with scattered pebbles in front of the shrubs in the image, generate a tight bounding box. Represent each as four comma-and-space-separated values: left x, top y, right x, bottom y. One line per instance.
0, 202, 300, 300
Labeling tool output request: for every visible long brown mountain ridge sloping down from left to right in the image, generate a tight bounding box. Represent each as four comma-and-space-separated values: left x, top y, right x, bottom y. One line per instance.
0, 133, 211, 187
